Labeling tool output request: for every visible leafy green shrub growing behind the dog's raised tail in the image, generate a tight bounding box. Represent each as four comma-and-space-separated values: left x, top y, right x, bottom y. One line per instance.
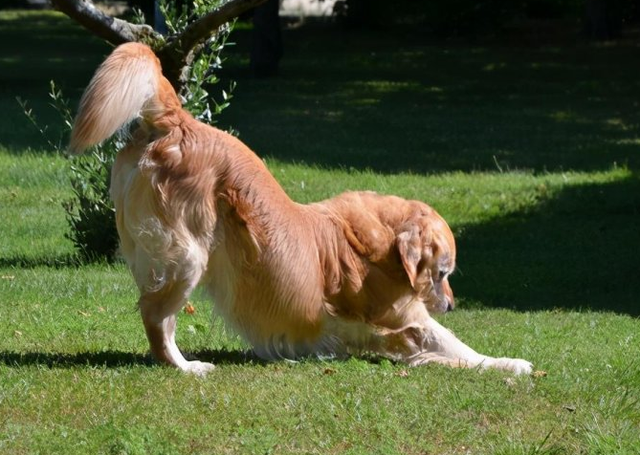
18, 0, 235, 262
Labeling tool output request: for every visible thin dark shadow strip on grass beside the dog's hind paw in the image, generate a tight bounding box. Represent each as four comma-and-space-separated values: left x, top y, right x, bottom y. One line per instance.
0, 349, 265, 368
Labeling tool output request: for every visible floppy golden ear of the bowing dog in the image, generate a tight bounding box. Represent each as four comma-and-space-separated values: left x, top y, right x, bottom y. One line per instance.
396, 223, 432, 291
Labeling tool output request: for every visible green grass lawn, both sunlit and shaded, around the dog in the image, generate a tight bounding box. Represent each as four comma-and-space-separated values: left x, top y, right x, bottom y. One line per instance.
0, 11, 640, 455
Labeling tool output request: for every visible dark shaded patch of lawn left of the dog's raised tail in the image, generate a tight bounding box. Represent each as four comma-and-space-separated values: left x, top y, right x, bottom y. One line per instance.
0, 12, 110, 153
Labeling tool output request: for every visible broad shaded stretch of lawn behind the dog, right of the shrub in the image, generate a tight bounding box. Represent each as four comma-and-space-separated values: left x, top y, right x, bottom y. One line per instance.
220, 27, 640, 173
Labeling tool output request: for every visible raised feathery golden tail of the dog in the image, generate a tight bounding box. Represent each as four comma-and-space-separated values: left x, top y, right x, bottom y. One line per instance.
69, 43, 180, 153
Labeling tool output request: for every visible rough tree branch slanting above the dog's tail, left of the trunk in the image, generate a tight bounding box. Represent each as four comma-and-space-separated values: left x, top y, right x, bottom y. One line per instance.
51, 0, 160, 45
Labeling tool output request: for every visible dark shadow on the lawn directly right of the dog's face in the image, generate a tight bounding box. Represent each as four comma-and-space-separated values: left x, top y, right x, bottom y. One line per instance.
452, 171, 640, 316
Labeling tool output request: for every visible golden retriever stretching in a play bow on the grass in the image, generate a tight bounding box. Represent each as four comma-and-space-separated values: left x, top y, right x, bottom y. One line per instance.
69, 43, 532, 375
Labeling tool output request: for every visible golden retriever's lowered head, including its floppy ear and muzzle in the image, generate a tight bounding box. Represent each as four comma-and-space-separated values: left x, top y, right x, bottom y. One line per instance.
396, 207, 456, 313
